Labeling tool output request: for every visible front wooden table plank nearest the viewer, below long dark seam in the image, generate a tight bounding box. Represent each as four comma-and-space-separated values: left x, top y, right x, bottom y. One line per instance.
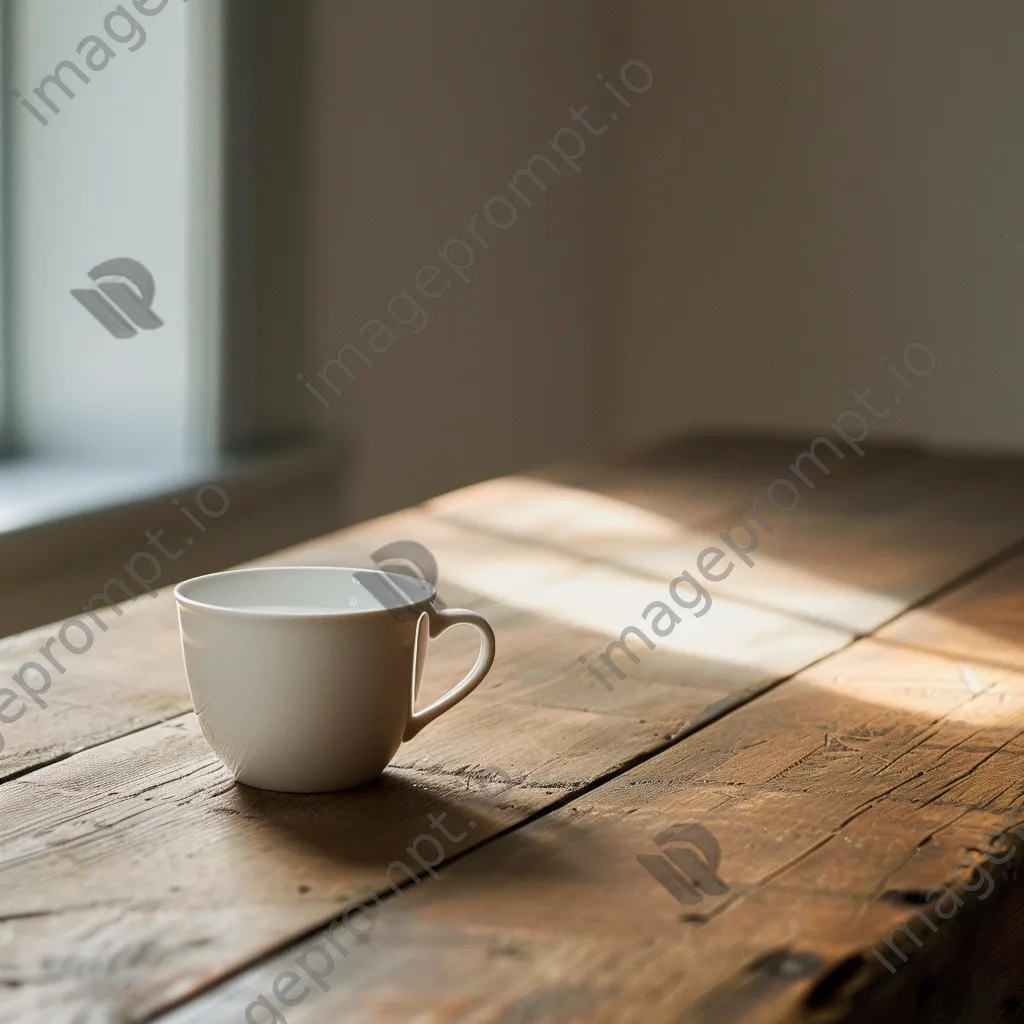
167, 557, 1024, 1024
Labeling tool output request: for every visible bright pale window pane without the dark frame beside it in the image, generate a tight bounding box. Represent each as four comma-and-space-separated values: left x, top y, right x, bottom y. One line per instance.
7, 0, 223, 469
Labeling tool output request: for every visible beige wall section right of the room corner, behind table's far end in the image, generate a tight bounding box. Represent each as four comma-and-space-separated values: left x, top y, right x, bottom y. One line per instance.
616, 0, 1024, 447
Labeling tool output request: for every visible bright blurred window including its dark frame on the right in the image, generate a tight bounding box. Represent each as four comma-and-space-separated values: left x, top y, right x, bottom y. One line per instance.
0, 0, 334, 632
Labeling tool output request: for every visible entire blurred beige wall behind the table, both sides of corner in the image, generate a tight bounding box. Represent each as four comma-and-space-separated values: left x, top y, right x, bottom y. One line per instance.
307, 0, 1024, 518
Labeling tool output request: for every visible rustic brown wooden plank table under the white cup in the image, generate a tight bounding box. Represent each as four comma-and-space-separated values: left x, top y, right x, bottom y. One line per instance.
6, 439, 1024, 1024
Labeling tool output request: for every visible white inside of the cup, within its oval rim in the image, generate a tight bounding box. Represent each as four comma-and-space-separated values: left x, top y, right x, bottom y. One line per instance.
174, 565, 436, 615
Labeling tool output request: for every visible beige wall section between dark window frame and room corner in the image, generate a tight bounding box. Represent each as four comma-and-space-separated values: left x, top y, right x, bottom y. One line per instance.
305, 0, 626, 518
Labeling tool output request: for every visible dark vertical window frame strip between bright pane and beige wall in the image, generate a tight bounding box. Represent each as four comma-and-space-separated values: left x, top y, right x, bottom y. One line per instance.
220, 0, 314, 453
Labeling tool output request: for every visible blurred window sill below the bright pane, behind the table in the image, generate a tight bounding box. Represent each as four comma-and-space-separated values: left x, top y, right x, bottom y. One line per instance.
0, 446, 341, 636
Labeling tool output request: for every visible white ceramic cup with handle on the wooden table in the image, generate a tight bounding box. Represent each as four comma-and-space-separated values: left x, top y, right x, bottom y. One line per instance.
174, 566, 495, 793
